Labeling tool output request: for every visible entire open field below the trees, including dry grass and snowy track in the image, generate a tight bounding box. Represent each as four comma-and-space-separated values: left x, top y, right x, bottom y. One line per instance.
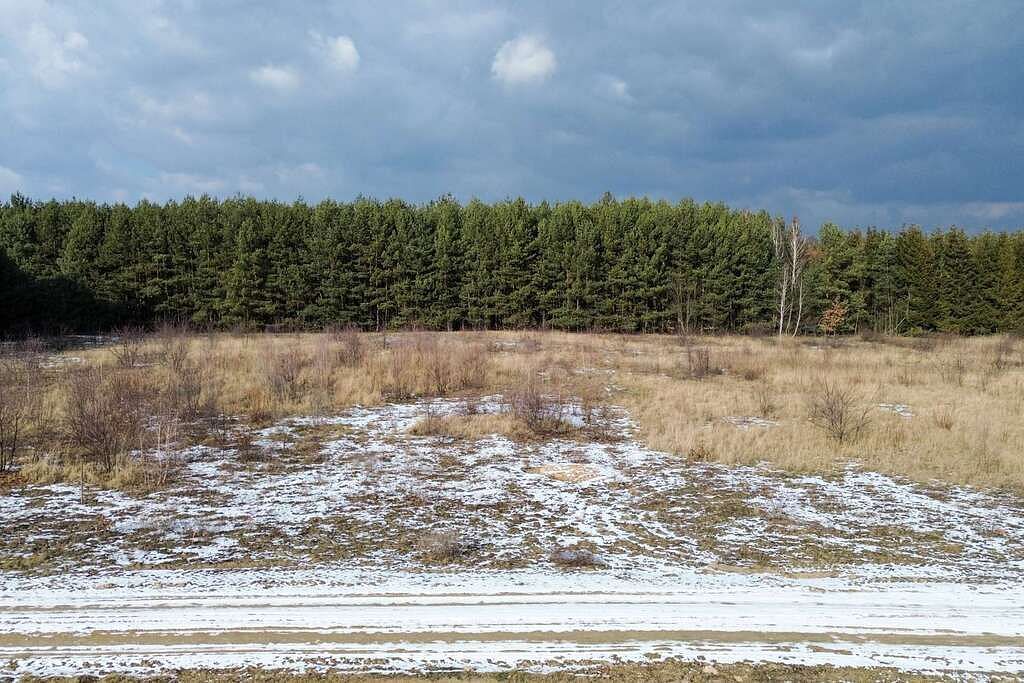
0, 328, 1024, 680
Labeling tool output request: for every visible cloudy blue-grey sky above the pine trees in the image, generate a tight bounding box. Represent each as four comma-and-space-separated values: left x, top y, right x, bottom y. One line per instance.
0, 0, 1024, 230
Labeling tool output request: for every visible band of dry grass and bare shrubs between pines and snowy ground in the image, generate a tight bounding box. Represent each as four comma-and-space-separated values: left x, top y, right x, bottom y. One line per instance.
0, 328, 1024, 492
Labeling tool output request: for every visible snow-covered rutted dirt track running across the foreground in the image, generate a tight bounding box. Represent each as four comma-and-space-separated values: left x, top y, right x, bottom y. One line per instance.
0, 569, 1024, 674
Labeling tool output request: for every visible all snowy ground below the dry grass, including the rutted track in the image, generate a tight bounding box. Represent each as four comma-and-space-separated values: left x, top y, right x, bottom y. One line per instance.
0, 401, 1024, 673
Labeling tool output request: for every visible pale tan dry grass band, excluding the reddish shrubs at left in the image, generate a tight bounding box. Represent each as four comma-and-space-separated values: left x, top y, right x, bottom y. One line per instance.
8, 330, 1024, 492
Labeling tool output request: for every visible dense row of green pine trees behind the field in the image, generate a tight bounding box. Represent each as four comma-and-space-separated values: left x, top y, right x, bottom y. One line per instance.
0, 195, 1024, 334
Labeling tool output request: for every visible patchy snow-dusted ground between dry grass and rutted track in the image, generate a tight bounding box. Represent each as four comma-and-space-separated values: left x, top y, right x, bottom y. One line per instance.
0, 401, 1024, 582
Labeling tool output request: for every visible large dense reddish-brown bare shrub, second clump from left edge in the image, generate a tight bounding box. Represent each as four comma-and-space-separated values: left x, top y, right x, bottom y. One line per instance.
65, 368, 145, 472
